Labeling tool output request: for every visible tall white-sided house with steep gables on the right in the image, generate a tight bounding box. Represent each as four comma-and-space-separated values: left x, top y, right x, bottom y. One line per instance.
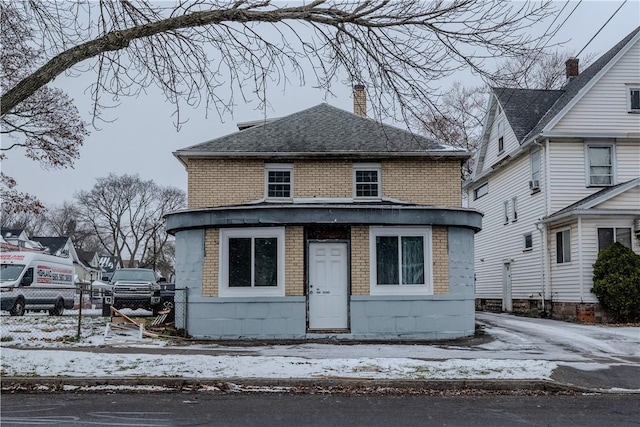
465, 27, 640, 321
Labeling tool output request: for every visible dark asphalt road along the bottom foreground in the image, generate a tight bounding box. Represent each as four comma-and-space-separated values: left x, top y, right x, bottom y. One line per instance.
0, 393, 640, 427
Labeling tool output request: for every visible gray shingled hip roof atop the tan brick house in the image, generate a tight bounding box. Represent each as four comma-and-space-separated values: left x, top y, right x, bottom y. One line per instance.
174, 103, 466, 157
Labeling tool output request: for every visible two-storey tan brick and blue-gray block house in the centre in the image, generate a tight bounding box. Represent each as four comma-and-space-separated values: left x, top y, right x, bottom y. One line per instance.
166, 87, 481, 339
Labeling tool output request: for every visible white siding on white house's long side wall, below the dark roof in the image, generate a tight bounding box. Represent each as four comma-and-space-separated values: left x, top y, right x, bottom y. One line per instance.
470, 150, 545, 299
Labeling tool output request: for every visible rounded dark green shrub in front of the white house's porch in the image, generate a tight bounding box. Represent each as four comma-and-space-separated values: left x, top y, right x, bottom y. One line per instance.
591, 242, 640, 322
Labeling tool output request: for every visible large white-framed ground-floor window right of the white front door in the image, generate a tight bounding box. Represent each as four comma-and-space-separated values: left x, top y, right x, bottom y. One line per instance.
370, 227, 433, 295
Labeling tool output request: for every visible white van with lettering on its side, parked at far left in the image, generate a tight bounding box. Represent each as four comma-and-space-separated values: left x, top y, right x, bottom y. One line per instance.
0, 252, 76, 316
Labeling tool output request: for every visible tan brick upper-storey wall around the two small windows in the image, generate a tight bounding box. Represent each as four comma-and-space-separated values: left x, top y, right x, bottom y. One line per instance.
188, 158, 461, 209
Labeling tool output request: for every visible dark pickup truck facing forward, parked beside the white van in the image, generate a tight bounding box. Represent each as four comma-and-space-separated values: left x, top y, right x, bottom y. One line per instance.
93, 268, 164, 316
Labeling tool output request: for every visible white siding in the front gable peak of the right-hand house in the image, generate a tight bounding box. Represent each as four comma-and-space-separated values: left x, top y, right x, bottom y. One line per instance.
552, 38, 640, 134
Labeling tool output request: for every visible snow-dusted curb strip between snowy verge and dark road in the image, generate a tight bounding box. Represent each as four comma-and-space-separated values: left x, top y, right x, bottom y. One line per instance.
2, 377, 608, 394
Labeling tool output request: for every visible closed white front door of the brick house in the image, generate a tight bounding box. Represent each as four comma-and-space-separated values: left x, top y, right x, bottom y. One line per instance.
309, 242, 349, 330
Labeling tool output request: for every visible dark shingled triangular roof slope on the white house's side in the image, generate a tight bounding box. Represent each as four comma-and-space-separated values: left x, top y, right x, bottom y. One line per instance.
493, 88, 564, 143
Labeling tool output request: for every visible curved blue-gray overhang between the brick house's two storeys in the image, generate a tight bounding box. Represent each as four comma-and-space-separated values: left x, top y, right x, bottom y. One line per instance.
165, 203, 482, 234
